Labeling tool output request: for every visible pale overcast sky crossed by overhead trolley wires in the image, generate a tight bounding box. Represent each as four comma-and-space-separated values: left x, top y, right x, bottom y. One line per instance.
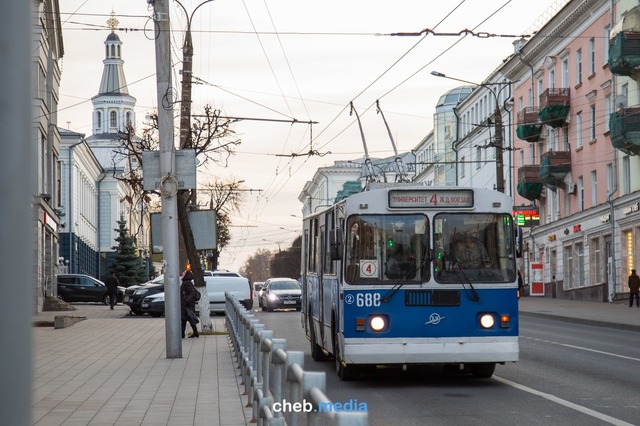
58, 0, 566, 270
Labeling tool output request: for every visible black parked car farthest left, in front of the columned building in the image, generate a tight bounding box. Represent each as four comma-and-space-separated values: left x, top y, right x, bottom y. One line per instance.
57, 274, 125, 305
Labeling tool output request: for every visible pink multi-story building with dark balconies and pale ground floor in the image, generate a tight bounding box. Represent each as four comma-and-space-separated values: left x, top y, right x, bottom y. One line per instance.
500, 0, 640, 301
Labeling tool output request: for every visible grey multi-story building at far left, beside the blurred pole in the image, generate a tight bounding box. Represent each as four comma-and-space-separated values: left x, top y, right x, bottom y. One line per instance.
32, 0, 64, 312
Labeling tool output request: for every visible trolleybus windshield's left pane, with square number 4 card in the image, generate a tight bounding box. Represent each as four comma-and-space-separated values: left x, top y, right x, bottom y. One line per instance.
346, 214, 429, 284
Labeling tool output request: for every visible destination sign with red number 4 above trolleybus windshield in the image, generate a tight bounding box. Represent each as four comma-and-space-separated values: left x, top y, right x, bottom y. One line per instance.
389, 189, 473, 209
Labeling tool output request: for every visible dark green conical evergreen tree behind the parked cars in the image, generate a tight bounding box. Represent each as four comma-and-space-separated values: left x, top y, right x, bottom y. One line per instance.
111, 216, 146, 287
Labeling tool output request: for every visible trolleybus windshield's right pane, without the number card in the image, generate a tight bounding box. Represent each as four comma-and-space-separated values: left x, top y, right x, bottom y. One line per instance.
433, 213, 516, 283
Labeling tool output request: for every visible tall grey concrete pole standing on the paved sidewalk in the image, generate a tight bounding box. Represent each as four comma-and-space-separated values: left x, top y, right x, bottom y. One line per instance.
153, 0, 182, 358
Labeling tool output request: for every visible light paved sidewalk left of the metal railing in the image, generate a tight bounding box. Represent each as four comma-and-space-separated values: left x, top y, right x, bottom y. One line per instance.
32, 304, 251, 426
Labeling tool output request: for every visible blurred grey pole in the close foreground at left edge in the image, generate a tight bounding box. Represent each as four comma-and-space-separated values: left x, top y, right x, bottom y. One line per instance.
0, 1, 32, 426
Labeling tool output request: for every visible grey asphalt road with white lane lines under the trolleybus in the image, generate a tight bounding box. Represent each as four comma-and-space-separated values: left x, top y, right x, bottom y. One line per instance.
255, 311, 640, 426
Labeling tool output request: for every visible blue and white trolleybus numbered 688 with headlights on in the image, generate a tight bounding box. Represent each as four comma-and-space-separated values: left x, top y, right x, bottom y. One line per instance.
301, 184, 519, 380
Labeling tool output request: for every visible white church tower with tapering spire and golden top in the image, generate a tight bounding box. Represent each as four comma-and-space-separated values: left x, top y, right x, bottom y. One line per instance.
91, 12, 136, 139
